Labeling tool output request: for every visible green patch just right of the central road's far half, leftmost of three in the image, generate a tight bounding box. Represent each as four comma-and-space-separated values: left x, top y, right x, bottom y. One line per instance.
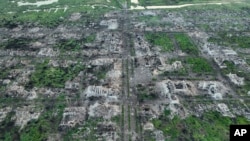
145, 33, 174, 52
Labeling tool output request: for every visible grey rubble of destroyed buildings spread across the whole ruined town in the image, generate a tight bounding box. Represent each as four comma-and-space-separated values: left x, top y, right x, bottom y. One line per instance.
0, 5, 250, 141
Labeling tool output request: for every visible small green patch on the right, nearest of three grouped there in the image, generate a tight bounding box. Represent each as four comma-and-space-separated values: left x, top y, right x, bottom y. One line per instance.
186, 57, 213, 74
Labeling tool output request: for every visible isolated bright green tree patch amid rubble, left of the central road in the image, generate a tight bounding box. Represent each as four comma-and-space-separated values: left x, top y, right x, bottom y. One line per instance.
28, 60, 84, 88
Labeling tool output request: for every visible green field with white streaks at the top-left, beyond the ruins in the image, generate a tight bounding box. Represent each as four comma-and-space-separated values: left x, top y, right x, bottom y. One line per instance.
0, 0, 121, 28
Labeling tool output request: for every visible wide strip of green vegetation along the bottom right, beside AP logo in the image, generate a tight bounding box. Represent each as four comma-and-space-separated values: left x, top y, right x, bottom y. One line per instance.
152, 111, 249, 141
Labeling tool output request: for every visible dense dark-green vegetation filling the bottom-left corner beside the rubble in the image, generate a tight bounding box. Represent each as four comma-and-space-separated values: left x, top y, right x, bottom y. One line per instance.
0, 94, 65, 141
